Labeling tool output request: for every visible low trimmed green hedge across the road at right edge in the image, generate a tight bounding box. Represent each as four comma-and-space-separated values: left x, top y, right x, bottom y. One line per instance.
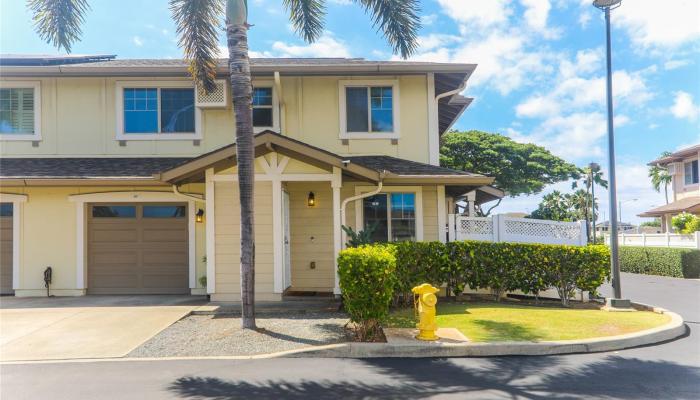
620, 246, 700, 278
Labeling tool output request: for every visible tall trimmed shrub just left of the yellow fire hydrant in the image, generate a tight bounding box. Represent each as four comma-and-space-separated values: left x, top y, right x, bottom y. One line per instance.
338, 245, 396, 341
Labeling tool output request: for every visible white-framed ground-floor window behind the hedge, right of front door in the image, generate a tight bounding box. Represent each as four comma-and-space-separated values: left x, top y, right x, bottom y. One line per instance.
362, 193, 416, 242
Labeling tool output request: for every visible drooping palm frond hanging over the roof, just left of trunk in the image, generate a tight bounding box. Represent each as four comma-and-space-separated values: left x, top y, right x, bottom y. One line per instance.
170, 0, 224, 92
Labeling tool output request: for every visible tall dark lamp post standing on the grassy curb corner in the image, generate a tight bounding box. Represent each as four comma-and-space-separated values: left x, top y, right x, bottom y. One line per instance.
593, 0, 631, 308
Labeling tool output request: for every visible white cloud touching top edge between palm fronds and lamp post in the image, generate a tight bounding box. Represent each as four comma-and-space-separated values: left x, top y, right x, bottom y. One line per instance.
438, 0, 512, 28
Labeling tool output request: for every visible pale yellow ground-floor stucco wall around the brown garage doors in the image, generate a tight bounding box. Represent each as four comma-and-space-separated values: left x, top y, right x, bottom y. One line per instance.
0, 185, 206, 296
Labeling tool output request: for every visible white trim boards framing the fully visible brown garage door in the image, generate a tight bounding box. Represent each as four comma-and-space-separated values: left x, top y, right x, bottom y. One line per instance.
68, 191, 197, 290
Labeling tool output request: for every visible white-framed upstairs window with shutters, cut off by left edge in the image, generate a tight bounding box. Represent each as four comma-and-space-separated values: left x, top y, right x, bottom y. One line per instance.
0, 82, 41, 140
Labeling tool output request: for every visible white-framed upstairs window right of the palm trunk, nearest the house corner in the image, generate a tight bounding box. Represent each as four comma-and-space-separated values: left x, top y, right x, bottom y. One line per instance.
340, 81, 398, 139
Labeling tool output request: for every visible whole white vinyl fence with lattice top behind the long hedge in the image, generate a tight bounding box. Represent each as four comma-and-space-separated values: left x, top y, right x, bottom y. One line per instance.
449, 214, 588, 246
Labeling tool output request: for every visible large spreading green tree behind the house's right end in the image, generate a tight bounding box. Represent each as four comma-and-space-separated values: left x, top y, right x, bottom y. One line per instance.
440, 131, 580, 214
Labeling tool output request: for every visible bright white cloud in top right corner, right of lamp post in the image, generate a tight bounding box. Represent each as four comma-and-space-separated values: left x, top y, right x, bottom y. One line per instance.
612, 0, 700, 48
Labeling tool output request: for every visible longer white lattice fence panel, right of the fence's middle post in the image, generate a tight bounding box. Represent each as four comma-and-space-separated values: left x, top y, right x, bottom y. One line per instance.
500, 217, 583, 245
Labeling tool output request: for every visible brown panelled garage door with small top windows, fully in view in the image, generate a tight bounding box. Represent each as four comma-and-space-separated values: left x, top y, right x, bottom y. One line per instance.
88, 203, 189, 294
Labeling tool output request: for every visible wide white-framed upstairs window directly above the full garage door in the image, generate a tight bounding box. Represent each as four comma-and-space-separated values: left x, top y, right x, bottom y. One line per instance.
117, 82, 200, 140
